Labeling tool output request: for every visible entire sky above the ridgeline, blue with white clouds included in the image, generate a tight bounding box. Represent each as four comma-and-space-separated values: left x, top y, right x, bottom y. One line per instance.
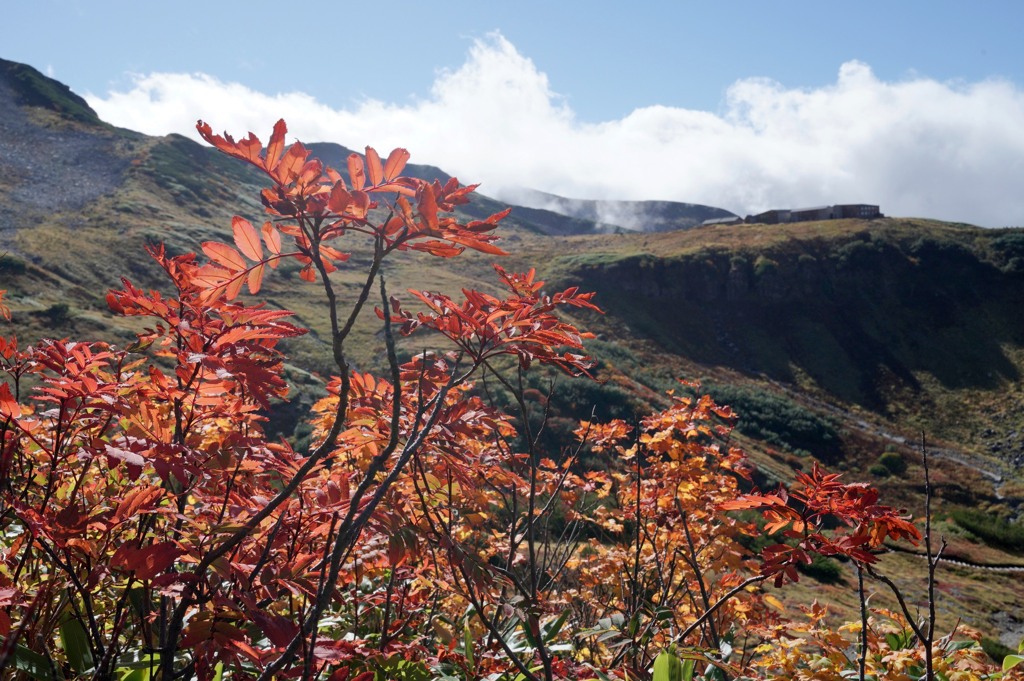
6, 0, 1024, 226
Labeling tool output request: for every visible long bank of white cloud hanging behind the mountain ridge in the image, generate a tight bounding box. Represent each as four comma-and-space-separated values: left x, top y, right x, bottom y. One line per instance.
86, 35, 1024, 226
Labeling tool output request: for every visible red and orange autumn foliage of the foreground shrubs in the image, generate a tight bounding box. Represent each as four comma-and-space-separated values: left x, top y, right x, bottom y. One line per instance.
0, 122, 1007, 681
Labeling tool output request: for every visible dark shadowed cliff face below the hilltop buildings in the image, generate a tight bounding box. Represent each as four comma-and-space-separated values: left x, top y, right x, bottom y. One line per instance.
575, 221, 1024, 409
